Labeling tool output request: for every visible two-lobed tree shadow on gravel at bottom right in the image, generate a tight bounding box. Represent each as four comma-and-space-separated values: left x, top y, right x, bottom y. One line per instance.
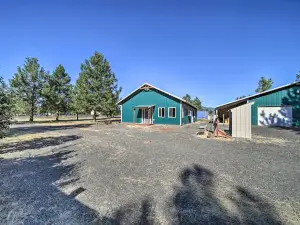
171, 165, 281, 224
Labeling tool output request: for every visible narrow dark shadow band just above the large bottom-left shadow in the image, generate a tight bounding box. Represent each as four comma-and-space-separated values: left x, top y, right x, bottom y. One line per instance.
0, 135, 81, 155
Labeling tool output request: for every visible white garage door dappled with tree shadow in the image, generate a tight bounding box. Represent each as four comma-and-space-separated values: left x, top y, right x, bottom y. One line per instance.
257, 106, 293, 127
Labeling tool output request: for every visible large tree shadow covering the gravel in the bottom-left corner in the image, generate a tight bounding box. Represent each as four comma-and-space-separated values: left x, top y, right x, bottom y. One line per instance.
0, 151, 98, 224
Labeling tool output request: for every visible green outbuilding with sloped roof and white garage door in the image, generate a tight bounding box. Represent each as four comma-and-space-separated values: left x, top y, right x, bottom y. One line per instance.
216, 81, 300, 127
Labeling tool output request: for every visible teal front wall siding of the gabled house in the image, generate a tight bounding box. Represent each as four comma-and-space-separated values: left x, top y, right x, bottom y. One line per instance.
122, 89, 180, 125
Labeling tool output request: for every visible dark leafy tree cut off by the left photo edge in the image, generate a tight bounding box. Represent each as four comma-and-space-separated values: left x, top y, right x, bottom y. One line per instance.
0, 77, 12, 139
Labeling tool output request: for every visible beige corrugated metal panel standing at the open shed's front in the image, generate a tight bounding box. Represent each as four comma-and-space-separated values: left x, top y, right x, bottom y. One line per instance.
229, 103, 253, 139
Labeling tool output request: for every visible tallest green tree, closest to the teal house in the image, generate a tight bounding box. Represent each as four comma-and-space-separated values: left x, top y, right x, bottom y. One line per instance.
79, 52, 121, 121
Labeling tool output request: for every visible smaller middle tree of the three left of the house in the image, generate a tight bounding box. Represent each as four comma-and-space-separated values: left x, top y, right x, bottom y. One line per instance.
42, 65, 72, 120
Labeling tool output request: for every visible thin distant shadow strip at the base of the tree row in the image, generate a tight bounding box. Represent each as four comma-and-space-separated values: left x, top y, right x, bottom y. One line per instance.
8, 124, 93, 136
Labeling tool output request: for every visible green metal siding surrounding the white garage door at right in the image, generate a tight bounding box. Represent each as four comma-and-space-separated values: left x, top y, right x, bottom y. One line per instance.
249, 86, 300, 126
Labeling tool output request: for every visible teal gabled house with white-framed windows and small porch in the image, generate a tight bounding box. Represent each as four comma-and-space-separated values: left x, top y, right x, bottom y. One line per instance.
118, 83, 197, 125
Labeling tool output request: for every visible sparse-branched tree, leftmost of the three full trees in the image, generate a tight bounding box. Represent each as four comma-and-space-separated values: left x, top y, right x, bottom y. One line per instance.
10, 58, 46, 122
